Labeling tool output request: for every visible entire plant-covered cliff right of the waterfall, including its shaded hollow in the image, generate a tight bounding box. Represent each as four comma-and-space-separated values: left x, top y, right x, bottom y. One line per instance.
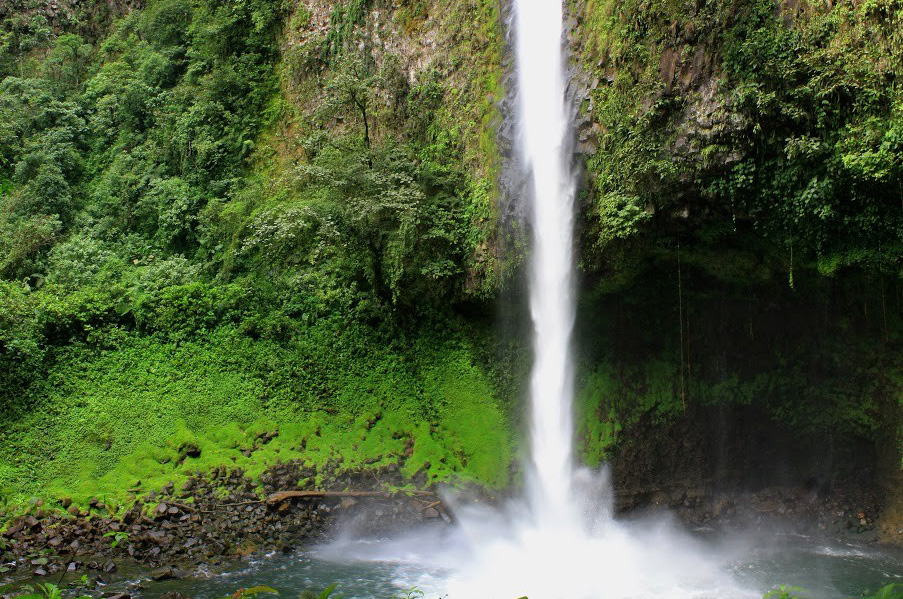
571, 0, 903, 478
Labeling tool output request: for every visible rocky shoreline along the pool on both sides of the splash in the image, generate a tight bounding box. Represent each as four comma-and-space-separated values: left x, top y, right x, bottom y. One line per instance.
0, 463, 903, 594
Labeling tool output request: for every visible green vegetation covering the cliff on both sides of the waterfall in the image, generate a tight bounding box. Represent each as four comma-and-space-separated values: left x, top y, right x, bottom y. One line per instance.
0, 0, 903, 504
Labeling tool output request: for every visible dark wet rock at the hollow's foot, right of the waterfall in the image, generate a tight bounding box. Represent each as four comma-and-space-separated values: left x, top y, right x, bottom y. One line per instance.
612, 408, 885, 541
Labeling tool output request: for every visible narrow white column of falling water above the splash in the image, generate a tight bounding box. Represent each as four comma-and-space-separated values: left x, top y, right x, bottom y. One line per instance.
514, 0, 575, 524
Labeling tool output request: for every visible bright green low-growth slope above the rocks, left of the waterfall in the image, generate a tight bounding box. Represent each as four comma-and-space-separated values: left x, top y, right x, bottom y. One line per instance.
0, 318, 511, 510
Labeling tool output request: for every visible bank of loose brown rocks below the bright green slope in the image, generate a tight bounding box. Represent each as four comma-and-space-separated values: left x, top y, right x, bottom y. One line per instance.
0, 464, 448, 580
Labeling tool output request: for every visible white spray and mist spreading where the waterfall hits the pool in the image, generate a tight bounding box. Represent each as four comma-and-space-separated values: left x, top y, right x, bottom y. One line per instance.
317, 471, 762, 599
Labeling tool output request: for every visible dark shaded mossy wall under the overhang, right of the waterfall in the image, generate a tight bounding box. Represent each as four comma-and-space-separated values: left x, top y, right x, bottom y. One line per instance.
577, 262, 901, 463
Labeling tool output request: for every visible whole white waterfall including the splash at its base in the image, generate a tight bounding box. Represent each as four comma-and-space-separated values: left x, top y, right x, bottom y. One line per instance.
326, 0, 761, 599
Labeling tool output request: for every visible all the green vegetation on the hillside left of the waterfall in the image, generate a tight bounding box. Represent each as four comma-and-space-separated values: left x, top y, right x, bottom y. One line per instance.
0, 0, 511, 508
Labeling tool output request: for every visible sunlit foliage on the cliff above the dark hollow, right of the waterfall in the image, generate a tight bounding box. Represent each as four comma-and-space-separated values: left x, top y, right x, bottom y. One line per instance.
576, 0, 903, 278
